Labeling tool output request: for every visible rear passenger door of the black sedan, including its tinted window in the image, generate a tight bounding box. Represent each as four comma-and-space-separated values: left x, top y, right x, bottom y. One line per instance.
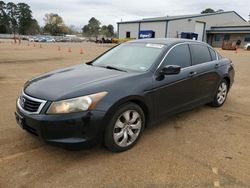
190, 43, 220, 103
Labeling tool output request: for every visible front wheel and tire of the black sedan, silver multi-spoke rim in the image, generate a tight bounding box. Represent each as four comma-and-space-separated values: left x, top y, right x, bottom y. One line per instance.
104, 103, 145, 152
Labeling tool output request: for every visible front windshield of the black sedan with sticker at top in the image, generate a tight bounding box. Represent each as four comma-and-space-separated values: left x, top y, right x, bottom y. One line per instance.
92, 43, 164, 72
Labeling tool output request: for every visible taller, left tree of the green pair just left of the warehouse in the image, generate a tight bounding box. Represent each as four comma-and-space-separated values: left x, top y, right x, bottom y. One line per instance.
82, 17, 101, 40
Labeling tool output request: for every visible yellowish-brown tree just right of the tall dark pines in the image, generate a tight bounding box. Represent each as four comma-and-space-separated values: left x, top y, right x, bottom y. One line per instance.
44, 13, 69, 35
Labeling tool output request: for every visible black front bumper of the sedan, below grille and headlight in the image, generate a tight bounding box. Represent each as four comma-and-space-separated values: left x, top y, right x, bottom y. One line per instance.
15, 107, 105, 147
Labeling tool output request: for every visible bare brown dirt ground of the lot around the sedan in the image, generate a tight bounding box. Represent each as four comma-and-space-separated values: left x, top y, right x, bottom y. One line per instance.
0, 41, 250, 188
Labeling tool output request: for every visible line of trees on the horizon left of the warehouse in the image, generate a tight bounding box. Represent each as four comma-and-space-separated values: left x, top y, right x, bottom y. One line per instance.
0, 1, 114, 38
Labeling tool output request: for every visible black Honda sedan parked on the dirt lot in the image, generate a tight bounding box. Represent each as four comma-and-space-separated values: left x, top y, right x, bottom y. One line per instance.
15, 39, 234, 151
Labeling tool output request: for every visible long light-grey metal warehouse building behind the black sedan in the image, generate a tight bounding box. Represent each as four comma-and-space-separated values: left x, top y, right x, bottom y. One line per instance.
117, 11, 250, 46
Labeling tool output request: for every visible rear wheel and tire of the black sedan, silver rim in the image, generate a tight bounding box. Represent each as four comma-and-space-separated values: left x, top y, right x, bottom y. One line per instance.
211, 79, 228, 107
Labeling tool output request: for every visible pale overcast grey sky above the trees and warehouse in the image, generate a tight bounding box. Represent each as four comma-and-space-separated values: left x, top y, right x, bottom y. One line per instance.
8, 0, 250, 28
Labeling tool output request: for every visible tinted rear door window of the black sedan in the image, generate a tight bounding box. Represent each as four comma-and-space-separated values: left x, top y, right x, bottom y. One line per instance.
190, 44, 211, 65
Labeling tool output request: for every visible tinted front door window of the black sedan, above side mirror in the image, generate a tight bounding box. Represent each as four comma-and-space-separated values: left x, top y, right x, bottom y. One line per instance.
163, 44, 191, 68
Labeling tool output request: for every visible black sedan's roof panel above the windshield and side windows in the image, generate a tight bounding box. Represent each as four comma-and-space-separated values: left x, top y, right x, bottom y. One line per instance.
129, 38, 207, 45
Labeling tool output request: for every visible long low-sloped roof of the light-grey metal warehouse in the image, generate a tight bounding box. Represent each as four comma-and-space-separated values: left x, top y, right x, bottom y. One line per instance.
117, 11, 246, 24
